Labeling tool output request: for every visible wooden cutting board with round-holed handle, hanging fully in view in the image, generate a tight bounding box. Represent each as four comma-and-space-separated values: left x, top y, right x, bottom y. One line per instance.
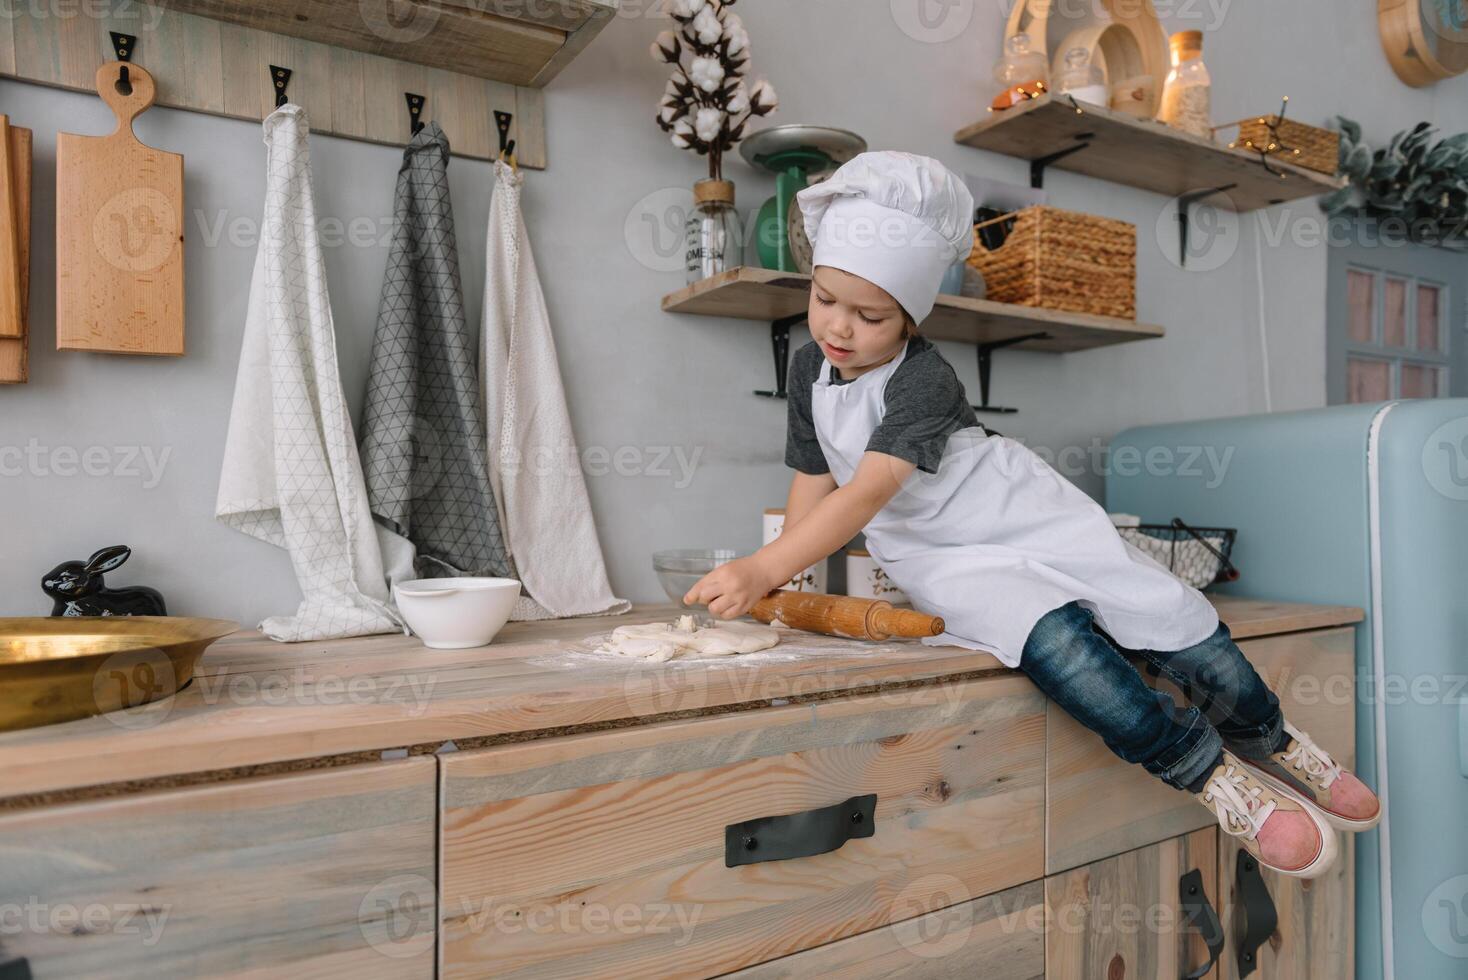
56, 62, 184, 355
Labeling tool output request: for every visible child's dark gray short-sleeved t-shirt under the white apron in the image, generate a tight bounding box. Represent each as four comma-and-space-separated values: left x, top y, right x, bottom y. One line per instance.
785, 336, 988, 474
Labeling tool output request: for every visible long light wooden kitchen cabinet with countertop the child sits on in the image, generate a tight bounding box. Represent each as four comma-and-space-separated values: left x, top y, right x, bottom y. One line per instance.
0, 600, 1359, 980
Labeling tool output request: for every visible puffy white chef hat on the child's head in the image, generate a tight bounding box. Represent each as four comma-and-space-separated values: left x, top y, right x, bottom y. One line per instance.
796, 150, 973, 323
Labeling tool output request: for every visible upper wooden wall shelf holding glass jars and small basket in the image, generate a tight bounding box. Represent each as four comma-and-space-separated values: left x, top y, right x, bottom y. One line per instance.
953, 95, 1346, 211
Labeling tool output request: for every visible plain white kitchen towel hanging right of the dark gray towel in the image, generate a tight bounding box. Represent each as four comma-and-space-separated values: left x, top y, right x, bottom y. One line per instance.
479, 161, 631, 619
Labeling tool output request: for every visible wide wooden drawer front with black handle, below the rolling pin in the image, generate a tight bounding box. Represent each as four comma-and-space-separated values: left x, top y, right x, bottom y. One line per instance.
440, 675, 1045, 977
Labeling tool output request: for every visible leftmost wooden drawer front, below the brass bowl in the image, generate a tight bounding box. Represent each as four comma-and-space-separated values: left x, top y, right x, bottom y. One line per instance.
0, 758, 436, 980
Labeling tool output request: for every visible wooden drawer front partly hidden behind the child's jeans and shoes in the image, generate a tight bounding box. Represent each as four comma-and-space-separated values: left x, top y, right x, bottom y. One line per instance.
1045, 626, 1355, 874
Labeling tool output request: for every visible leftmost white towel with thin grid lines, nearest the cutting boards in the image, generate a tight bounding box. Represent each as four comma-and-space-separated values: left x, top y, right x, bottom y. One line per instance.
214, 104, 402, 641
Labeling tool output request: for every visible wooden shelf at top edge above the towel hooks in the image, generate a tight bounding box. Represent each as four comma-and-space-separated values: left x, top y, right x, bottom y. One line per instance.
167, 0, 617, 86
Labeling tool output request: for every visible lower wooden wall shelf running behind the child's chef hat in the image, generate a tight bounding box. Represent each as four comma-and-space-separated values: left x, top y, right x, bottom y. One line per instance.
662, 266, 1164, 354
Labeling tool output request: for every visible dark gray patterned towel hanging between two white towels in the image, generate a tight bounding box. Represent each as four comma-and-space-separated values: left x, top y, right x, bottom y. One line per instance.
361, 123, 514, 581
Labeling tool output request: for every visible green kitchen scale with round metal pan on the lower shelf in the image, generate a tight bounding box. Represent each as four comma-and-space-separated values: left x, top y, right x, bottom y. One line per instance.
740, 123, 866, 273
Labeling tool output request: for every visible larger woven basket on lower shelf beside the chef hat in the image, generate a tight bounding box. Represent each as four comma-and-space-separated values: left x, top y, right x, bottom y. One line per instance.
969, 205, 1136, 320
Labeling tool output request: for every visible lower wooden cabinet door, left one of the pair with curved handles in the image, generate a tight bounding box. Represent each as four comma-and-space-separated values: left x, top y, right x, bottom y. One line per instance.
1045, 827, 1221, 980
